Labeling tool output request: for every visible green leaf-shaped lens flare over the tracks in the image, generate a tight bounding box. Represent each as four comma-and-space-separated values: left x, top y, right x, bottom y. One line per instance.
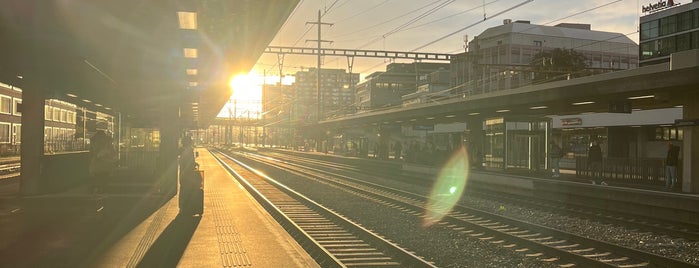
422, 147, 469, 227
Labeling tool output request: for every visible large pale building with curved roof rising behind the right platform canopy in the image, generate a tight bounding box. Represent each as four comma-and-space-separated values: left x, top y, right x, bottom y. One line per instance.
451, 20, 638, 95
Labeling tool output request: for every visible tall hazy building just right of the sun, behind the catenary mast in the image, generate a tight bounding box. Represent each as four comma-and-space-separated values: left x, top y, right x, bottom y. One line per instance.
292, 68, 359, 122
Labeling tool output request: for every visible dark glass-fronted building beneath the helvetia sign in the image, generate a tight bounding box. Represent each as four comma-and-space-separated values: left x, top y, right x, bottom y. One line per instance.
639, 0, 699, 66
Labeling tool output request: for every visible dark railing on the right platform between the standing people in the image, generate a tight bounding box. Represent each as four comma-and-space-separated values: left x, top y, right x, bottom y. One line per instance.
575, 156, 682, 185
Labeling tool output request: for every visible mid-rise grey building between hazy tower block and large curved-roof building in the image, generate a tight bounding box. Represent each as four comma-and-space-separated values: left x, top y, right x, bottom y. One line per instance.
356, 62, 449, 110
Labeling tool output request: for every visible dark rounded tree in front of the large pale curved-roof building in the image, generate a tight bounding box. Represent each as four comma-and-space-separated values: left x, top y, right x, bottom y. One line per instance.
531, 48, 589, 83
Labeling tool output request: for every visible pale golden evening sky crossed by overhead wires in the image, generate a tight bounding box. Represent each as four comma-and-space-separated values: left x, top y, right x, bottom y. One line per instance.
220, 0, 644, 116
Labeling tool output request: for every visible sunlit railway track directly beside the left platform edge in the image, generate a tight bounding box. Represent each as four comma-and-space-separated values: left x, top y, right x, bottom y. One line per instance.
214, 152, 434, 267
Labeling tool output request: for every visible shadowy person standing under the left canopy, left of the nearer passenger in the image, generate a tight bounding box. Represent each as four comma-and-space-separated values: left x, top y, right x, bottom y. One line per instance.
89, 130, 118, 194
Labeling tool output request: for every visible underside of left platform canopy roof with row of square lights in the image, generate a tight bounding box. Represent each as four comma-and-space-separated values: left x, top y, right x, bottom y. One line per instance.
0, 0, 299, 128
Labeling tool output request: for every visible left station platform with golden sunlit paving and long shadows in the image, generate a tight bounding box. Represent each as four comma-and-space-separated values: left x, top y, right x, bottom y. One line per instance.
0, 148, 319, 267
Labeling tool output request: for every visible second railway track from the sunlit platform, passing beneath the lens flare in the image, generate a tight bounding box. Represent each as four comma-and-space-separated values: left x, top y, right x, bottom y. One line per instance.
227, 149, 696, 267
